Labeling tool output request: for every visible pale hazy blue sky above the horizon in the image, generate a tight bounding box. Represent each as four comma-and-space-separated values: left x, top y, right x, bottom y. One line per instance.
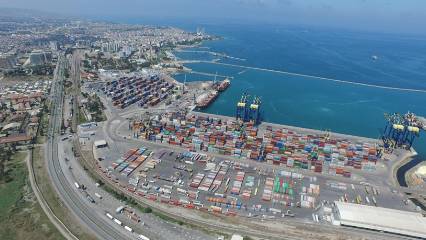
0, 0, 426, 35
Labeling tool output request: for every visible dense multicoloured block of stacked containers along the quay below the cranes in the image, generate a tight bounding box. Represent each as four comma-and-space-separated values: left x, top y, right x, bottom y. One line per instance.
133, 113, 378, 177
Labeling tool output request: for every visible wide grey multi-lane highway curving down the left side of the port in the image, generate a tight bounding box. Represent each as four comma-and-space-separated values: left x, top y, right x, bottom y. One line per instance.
46, 56, 129, 240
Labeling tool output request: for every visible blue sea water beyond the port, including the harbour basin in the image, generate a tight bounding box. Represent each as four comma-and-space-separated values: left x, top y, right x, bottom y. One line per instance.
112, 17, 426, 177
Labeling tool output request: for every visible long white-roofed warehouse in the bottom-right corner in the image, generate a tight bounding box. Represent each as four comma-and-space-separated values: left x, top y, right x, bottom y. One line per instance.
335, 201, 426, 238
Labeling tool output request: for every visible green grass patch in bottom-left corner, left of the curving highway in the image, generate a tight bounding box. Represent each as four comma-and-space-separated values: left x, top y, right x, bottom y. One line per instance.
0, 152, 64, 239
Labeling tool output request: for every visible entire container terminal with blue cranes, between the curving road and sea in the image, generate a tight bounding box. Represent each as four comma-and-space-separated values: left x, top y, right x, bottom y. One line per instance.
74, 73, 426, 237
